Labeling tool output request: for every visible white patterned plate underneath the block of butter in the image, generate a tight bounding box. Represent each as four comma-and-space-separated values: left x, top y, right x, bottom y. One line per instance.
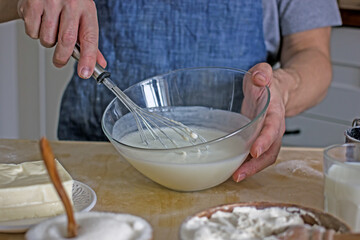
0, 180, 97, 233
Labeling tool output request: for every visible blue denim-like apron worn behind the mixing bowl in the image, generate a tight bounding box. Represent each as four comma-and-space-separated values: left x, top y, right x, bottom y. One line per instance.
58, 0, 266, 141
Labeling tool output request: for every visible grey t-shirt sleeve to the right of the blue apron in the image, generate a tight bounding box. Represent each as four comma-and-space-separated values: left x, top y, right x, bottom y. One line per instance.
262, 0, 341, 64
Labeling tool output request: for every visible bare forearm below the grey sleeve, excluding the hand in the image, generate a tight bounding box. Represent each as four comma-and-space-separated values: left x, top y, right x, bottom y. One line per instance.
274, 29, 332, 117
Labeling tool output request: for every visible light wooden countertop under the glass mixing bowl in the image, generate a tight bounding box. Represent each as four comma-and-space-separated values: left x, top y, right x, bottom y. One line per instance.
0, 139, 323, 240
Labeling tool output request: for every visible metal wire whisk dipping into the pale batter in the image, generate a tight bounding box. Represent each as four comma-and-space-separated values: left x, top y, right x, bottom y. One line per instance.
72, 44, 206, 148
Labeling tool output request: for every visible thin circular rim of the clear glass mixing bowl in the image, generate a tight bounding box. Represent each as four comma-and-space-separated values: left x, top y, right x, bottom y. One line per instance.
101, 67, 270, 151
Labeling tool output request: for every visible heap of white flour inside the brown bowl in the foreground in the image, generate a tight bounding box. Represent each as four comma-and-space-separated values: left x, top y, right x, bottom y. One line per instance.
180, 207, 320, 240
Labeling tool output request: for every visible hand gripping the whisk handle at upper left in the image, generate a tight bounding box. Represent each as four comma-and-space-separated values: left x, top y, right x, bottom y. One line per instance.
17, 0, 106, 78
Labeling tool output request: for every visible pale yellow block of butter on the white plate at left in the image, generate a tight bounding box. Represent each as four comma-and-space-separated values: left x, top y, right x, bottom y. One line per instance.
0, 160, 73, 221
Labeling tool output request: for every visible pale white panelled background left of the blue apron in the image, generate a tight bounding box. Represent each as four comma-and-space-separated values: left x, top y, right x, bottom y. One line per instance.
0, 21, 74, 140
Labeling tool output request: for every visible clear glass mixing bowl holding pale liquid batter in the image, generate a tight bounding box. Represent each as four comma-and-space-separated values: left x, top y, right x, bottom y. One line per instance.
102, 67, 270, 191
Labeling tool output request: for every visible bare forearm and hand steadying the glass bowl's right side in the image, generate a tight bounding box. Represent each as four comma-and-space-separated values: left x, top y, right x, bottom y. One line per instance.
233, 27, 331, 182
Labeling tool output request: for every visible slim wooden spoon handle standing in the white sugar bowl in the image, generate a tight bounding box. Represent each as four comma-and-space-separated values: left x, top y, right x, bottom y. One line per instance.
40, 137, 78, 238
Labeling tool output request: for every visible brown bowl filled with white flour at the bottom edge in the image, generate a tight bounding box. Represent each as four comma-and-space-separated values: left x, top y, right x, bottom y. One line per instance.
179, 202, 350, 240
